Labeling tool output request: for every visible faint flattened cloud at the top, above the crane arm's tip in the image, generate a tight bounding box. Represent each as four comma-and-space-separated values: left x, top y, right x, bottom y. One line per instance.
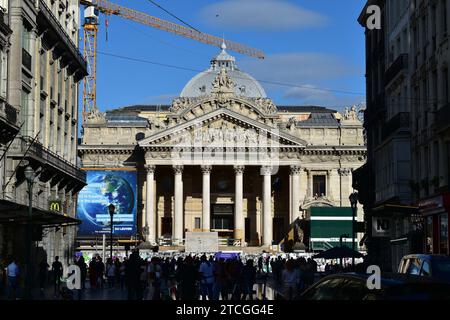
200, 0, 328, 31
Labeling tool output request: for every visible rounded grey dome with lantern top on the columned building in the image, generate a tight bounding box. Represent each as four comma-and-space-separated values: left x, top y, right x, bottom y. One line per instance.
180, 43, 267, 98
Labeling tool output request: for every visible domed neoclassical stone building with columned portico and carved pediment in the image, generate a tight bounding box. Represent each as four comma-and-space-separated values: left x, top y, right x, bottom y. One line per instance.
78, 46, 366, 246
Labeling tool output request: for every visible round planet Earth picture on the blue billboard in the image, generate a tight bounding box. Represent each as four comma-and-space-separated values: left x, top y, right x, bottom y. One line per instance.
79, 173, 135, 227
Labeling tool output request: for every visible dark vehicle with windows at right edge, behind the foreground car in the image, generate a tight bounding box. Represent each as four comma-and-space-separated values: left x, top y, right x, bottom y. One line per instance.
398, 254, 450, 282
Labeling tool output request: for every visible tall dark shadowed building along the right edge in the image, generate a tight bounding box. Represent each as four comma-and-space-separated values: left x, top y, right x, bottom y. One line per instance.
355, 0, 450, 270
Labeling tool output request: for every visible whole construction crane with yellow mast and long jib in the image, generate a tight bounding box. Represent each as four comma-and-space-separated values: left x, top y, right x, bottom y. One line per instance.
80, 0, 264, 122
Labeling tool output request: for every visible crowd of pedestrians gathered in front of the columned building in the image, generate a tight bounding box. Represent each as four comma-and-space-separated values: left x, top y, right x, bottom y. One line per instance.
0, 251, 326, 300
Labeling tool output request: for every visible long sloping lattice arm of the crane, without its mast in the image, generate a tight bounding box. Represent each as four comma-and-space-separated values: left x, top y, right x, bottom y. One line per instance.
80, 0, 264, 59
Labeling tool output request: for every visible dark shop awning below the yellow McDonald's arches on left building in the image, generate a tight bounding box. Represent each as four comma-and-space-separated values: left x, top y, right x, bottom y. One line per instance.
0, 200, 81, 228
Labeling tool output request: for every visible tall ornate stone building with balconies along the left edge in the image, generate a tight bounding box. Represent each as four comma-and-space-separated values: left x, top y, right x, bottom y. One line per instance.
0, 0, 87, 272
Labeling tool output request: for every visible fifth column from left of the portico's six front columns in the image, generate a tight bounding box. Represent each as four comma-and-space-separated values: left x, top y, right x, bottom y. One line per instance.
261, 166, 273, 246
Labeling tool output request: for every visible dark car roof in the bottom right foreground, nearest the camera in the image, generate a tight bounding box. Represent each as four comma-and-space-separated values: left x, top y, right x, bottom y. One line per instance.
300, 273, 450, 300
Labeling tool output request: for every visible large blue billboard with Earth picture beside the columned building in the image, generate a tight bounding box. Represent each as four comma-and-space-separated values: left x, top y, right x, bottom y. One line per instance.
77, 170, 137, 237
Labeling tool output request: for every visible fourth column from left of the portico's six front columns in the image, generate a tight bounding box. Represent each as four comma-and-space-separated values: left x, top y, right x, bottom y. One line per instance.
234, 166, 245, 243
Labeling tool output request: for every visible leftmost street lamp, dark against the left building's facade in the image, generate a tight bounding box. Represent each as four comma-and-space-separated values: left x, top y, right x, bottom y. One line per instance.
24, 166, 36, 299
